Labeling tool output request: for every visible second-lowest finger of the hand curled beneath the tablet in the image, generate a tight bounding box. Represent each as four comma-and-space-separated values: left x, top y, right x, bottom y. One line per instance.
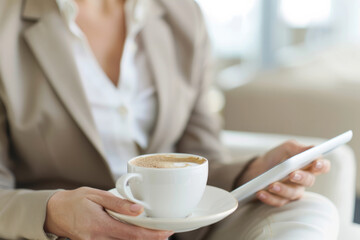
268, 182, 305, 201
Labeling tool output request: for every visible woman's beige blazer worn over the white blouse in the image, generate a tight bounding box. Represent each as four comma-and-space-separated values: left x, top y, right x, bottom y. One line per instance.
0, 0, 245, 239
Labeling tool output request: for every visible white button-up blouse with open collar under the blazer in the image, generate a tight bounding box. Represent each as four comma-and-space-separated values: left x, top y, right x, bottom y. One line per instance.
57, 0, 157, 179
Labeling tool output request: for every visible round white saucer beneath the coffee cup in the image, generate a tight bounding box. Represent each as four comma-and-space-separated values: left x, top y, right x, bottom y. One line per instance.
106, 186, 238, 232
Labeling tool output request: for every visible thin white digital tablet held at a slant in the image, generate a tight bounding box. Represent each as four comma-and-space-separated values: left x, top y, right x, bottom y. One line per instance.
231, 131, 353, 205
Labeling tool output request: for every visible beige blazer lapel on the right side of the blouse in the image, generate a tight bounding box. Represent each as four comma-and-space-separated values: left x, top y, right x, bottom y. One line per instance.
141, 1, 177, 153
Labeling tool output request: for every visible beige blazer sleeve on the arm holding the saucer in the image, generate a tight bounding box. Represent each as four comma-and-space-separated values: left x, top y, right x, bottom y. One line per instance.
0, 98, 56, 240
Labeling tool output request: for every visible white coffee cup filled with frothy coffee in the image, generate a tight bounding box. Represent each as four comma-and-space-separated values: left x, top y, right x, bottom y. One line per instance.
116, 153, 208, 218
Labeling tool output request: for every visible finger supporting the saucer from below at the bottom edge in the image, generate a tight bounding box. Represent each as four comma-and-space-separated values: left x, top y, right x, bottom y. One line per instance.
106, 217, 174, 240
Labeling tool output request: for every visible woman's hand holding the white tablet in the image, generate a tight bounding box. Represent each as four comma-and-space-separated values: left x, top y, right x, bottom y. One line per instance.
240, 141, 330, 207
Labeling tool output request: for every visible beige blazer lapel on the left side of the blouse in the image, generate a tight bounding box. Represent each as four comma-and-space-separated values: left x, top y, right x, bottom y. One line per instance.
24, 1, 105, 159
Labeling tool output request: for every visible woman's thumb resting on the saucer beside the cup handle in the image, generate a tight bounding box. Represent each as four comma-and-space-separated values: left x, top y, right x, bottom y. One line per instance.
88, 189, 144, 216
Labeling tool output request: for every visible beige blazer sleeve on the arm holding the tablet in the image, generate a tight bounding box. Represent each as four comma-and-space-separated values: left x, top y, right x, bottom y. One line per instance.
176, 5, 248, 191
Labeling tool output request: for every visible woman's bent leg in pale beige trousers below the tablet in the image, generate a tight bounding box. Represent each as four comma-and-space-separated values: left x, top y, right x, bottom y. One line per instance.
174, 192, 339, 240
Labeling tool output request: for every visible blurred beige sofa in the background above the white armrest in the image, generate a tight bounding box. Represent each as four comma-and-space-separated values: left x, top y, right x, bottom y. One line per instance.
223, 44, 360, 197
